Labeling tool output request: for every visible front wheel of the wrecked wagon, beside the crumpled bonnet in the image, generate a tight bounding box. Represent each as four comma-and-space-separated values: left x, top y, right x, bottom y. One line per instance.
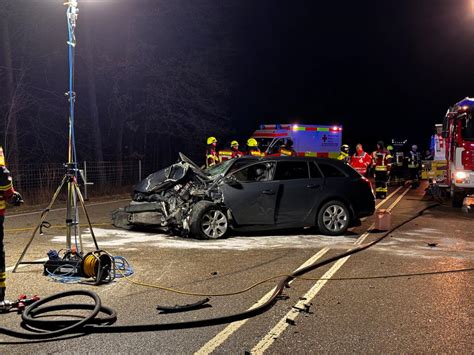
190, 201, 229, 239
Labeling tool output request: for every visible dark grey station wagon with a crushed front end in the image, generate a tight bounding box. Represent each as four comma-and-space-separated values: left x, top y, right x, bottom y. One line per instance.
112, 153, 375, 239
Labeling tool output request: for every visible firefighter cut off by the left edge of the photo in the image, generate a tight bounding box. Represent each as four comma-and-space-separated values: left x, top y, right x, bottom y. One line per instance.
0, 147, 23, 308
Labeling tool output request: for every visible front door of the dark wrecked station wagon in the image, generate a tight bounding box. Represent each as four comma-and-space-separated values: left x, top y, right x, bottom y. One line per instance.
221, 162, 278, 225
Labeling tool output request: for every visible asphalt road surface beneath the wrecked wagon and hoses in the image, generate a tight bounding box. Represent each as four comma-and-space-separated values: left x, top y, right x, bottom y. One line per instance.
0, 189, 474, 354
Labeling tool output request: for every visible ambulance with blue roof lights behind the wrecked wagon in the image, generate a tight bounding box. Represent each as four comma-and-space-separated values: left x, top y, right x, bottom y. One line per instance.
252, 124, 342, 158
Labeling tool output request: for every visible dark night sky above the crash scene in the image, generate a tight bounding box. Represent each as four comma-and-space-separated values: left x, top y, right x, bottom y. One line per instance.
0, 0, 474, 165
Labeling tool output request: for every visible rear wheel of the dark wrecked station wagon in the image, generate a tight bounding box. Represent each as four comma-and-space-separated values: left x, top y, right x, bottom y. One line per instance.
318, 200, 350, 235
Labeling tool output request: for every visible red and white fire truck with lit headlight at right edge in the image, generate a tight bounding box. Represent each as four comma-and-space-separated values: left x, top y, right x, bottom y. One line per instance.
442, 97, 474, 207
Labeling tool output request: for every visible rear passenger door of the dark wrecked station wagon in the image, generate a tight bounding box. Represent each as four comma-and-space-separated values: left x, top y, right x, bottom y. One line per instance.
273, 160, 323, 225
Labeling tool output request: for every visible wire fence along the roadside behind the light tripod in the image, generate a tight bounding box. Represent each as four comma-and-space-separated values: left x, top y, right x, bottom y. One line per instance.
10, 160, 143, 203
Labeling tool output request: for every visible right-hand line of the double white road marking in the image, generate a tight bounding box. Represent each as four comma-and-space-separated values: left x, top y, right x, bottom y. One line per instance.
250, 188, 410, 354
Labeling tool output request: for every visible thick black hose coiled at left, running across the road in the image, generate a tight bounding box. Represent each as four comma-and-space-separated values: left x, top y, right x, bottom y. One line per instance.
0, 203, 439, 339
